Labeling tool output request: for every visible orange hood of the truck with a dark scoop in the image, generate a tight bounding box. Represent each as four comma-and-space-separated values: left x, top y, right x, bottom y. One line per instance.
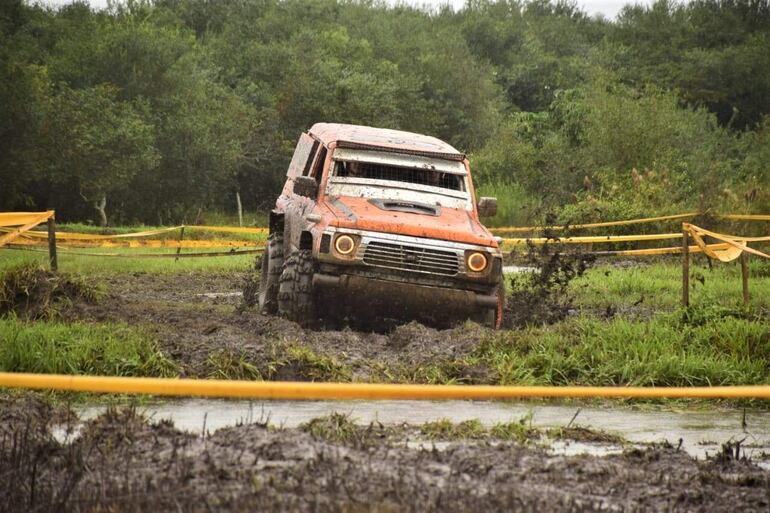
326, 196, 497, 247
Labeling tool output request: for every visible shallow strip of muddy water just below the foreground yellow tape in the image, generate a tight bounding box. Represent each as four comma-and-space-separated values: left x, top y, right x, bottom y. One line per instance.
70, 399, 770, 461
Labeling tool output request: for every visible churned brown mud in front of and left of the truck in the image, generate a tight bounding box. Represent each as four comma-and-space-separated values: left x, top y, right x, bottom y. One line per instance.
67, 273, 495, 383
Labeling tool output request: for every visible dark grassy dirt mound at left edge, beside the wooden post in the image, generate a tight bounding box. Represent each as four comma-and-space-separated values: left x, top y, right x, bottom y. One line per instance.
0, 265, 99, 320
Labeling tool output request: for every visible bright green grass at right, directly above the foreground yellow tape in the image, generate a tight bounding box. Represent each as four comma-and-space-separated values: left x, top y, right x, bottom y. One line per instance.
477, 312, 770, 386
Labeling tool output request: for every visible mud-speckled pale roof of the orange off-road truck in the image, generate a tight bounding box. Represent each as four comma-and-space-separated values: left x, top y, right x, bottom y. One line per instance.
310, 123, 465, 160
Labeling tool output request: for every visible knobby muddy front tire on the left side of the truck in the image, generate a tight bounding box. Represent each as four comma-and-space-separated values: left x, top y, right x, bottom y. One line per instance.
278, 249, 318, 328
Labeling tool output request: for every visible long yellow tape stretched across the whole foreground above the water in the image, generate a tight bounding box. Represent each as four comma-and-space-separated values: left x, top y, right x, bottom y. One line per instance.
0, 372, 770, 401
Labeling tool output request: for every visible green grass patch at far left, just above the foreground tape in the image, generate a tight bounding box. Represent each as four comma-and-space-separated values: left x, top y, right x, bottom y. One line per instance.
0, 317, 177, 377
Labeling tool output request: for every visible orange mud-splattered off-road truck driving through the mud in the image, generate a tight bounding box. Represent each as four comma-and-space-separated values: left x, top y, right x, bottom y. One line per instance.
259, 123, 505, 327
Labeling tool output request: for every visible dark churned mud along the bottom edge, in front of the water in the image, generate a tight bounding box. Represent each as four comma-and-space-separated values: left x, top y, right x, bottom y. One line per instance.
0, 396, 770, 513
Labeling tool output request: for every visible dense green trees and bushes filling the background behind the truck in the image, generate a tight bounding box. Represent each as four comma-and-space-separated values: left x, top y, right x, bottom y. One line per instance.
0, 0, 770, 224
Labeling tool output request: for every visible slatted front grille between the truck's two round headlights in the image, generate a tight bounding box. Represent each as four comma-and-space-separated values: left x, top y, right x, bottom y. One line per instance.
364, 241, 458, 276
